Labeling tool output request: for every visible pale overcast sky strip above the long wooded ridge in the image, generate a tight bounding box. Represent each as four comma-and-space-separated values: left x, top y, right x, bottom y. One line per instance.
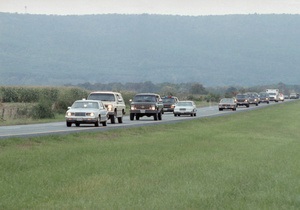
0, 0, 300, 16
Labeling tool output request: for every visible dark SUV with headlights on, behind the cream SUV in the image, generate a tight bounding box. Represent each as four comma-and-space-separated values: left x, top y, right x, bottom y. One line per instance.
130, 93, 164, 120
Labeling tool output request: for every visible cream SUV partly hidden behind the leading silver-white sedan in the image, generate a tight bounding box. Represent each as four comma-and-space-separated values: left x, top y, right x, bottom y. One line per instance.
87, 91, 126, 124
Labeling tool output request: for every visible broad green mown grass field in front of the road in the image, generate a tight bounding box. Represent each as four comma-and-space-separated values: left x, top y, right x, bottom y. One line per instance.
0, 102, 300, 209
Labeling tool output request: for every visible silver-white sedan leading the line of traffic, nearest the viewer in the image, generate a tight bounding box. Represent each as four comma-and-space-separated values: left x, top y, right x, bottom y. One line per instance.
65, 100, 108, 127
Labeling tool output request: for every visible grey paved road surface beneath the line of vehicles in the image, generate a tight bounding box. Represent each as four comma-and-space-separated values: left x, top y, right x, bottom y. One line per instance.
0, 100, 291, 139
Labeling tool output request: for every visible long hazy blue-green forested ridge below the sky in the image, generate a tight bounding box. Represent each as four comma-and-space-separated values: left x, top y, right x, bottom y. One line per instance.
0, 13, 300, 86
